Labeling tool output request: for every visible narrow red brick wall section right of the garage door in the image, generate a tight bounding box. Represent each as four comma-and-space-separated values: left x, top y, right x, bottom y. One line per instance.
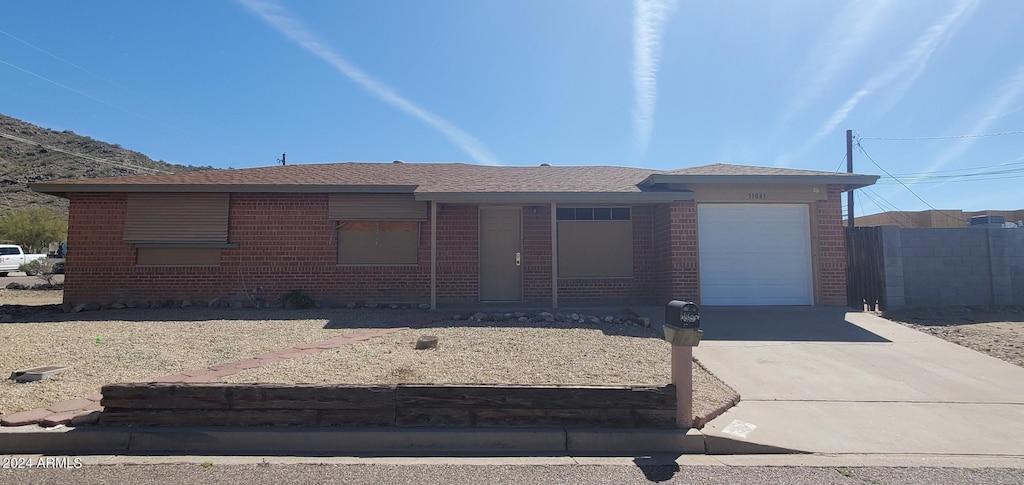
814, 185, 847, 306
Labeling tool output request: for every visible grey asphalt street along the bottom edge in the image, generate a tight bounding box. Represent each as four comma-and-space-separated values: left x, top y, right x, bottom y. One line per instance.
0, 460, 1024, 485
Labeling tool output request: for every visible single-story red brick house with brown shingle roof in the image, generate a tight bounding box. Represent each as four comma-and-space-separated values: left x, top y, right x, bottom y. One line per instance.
33, 164, 873, 307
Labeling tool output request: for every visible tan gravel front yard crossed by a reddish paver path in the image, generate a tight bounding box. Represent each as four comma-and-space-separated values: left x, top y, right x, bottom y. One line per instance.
0, 291, 735, 423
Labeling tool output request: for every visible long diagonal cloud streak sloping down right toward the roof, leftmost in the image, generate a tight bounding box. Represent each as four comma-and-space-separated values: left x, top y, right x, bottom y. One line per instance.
238, 0, 502, 165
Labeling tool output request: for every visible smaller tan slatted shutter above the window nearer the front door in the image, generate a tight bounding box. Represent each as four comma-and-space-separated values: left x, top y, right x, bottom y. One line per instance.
328, 193, 427, 221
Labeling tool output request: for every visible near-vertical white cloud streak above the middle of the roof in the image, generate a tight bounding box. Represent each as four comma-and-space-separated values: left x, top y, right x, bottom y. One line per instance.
633, 0, 676, 158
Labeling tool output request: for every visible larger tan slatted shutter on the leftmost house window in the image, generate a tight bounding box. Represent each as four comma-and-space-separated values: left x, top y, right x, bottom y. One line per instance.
124, 193, 229, 243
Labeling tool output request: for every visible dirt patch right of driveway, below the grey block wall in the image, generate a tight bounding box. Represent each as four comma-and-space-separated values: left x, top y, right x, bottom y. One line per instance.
883, 307, 1024, 367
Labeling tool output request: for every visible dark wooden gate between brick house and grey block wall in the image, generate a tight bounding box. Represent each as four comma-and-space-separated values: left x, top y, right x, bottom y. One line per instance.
846, 227, 886, 311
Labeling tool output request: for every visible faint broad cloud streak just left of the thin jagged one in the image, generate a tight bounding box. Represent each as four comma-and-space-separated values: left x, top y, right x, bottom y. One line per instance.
778, 0, 895, 128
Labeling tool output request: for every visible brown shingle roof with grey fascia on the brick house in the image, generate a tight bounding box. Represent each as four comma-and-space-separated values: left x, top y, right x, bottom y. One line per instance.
31, 163, 878, 202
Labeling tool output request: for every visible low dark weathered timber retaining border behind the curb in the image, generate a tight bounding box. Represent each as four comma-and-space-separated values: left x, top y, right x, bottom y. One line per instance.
99, 383, 676, 428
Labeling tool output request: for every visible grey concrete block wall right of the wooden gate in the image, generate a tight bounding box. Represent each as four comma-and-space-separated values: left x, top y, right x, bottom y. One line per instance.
882, 226, 1024, 309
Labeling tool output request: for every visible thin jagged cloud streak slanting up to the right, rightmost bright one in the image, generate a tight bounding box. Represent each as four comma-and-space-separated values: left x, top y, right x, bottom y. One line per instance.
776, 0, 978, 164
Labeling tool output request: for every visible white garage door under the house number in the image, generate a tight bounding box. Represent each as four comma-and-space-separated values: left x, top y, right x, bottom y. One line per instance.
697, 204, 814, 305
